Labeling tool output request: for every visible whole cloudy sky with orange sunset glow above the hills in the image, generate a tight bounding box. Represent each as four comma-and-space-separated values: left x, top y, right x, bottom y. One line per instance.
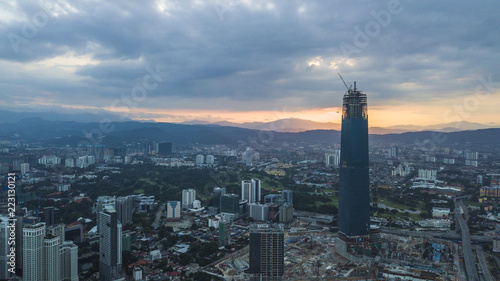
0, 0, 500, 126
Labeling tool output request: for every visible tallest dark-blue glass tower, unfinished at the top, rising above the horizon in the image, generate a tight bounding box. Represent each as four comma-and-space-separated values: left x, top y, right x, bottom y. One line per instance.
338, 82, 370, 248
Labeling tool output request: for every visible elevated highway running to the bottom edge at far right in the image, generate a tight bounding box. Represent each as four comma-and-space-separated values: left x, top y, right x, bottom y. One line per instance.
453, 198, 479, 281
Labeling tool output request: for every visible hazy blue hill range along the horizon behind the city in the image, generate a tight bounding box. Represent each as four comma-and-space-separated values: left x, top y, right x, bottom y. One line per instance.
0, 118, 500, 146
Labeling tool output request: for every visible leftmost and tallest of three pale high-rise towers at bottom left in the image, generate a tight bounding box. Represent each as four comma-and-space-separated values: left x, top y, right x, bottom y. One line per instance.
22, 222, 45, 281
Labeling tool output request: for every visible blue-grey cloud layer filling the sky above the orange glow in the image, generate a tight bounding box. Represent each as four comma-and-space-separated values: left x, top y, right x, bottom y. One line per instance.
0, 0, 500, 110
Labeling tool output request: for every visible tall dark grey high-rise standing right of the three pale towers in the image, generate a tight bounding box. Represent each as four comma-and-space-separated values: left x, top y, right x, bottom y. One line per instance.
99, 205, 122, 281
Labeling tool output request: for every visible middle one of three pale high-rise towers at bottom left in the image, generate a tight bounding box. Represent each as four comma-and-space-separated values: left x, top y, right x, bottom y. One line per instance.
43, 234, 61, 281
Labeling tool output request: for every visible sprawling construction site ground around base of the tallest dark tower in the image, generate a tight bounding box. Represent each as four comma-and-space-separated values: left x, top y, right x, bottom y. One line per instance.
205, 231, 459, 280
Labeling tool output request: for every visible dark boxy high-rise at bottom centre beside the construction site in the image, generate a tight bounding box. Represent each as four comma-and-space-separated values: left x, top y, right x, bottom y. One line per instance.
247, 224, 285, 280
